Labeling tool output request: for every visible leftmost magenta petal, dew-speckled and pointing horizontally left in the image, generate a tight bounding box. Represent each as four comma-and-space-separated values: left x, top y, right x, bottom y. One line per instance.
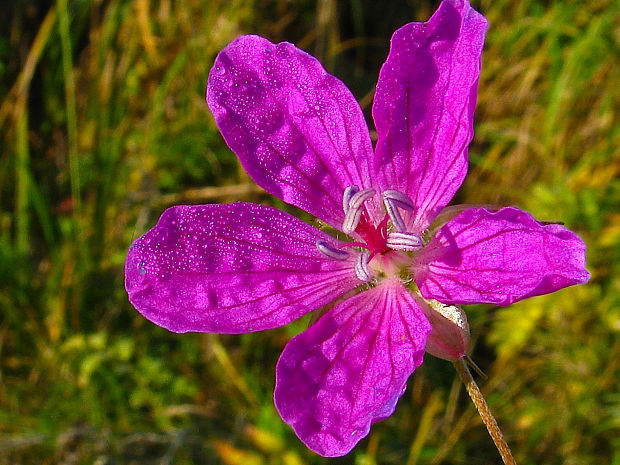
125, 203, 361, 333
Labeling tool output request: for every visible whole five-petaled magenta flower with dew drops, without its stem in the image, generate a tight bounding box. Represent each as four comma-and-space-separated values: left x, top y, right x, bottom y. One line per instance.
125, 0, 589, 456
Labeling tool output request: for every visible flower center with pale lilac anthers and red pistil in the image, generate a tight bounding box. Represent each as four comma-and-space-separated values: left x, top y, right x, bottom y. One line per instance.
317, 186, 423, 282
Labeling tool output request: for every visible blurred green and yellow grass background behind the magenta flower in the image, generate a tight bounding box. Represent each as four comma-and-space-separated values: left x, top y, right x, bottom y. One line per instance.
0, 0, 620, 465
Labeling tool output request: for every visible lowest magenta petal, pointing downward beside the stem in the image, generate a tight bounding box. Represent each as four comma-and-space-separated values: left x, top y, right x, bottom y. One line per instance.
274, 281, 430, 457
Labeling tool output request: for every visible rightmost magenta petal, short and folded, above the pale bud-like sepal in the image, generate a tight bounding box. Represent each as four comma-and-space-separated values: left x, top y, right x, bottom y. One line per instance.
414, 207, 590, 305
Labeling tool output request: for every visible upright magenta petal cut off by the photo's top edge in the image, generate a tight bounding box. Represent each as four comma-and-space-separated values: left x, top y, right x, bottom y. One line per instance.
372, 0, 487, 234
